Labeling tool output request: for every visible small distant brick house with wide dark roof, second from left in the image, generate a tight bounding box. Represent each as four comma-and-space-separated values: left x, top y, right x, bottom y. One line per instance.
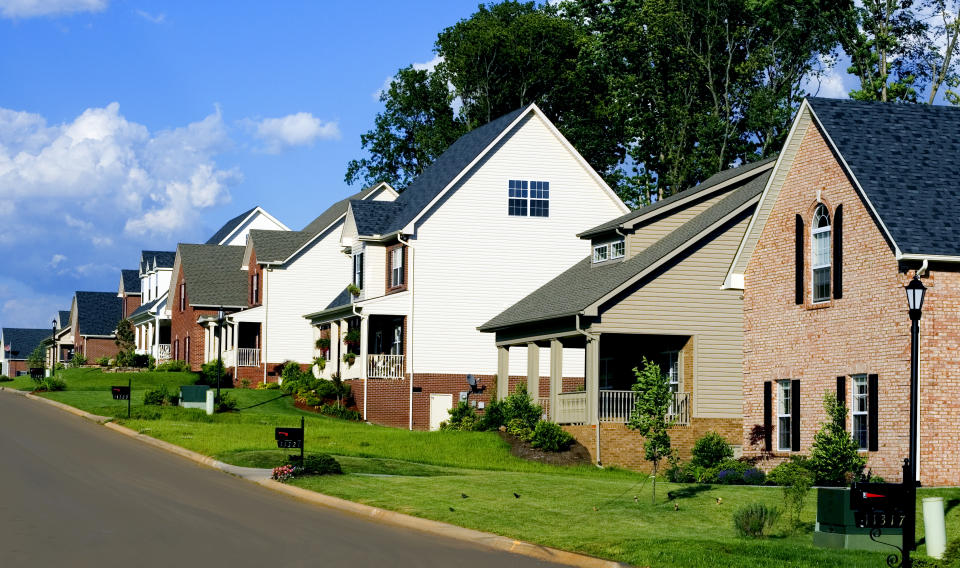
70, 292, 124, 363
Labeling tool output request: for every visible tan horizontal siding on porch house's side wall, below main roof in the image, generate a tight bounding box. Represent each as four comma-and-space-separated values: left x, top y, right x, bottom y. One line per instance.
591, 215, 749, 418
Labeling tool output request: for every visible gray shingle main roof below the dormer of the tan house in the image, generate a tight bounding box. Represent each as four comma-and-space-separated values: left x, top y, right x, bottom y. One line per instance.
479, 166, 770, 331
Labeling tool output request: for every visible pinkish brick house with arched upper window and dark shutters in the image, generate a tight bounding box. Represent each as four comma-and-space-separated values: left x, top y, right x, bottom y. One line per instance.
727, 99, 960, 485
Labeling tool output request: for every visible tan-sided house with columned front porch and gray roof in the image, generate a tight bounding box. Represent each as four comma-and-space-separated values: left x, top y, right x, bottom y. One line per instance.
480, 156, 773, 470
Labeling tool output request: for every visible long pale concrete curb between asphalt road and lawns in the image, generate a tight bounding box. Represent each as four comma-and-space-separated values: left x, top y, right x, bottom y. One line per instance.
0, 388, 629, 568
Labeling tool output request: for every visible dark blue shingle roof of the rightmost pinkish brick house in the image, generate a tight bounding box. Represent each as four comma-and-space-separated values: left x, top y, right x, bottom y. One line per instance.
808, 98, 960, 256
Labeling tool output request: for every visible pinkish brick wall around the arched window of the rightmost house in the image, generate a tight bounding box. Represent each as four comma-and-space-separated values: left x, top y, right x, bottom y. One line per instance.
743, 122, 960, 485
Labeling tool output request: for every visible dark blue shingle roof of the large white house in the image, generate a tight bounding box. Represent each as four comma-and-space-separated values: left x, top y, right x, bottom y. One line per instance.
350, 107, 529, 235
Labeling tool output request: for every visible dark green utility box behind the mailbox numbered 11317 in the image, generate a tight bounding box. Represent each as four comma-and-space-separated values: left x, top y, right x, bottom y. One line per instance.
813, 487, 903, 552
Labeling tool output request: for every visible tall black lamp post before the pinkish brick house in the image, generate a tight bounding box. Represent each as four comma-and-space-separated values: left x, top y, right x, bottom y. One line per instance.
902, 274, 927, 568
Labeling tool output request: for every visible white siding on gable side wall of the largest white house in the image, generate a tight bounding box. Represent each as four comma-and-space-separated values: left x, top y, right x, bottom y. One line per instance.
411, 112, 625, 376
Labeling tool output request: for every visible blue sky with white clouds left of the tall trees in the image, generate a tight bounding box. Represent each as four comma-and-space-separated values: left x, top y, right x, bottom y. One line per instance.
0, 0, 488, 327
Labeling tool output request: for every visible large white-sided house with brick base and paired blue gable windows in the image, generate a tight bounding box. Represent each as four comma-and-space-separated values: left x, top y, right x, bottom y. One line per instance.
304, 105, 628, 429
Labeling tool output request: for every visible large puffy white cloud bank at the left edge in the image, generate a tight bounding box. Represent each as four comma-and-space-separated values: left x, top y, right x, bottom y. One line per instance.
0, 103, 239, 239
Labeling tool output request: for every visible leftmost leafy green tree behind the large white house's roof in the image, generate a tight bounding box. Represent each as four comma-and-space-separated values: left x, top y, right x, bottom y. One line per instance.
345, 63, 467, 190
